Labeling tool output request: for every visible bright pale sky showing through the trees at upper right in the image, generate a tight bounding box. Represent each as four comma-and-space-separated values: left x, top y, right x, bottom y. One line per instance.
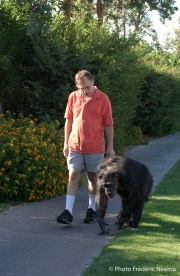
150, 0, 180, 45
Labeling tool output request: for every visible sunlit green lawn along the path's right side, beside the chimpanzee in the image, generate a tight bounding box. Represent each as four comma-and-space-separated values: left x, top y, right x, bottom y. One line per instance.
81, 160, 180, 276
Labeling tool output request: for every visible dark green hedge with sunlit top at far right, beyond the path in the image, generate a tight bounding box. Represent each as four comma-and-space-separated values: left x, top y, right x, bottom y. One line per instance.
133, 51, 180, 136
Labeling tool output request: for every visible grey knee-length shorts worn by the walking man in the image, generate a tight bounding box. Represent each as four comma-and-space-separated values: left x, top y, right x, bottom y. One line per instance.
67, 151, 104, 173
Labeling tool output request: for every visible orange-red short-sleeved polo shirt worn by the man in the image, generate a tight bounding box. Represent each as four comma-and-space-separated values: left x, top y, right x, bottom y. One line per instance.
64, 87, 113, 154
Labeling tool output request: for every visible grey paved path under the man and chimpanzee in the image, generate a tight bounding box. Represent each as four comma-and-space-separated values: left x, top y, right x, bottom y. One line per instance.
0, 132, 180, 276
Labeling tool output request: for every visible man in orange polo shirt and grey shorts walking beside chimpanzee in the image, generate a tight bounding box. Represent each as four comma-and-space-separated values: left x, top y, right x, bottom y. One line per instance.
57, 70, 115, 224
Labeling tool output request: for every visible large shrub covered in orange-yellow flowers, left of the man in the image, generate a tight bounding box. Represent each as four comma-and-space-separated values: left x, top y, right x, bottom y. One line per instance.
0, 112, 68, 202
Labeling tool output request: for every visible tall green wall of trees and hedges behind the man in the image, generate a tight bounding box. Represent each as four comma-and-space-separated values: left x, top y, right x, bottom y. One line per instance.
0, 0, 180, 151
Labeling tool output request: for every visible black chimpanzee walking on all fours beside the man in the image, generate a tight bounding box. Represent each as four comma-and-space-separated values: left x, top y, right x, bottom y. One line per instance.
96, 156, 153, 235
